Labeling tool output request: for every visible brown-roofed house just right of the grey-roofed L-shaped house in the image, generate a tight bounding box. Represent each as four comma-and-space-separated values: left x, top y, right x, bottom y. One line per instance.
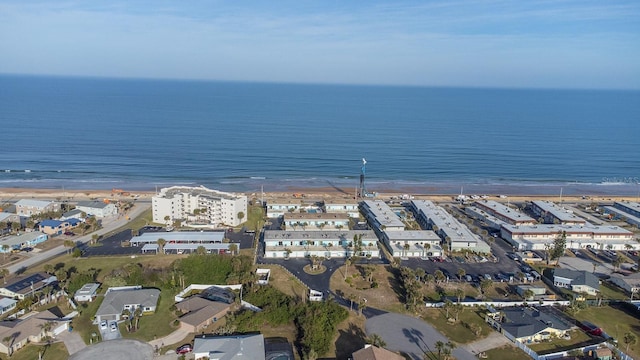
176, 295, 233, 333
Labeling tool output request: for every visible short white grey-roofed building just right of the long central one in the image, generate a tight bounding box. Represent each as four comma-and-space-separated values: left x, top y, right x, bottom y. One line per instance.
382, 230, 443, 258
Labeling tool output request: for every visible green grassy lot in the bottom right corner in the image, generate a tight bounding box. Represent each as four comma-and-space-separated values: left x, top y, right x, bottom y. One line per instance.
575, 306, 640, 359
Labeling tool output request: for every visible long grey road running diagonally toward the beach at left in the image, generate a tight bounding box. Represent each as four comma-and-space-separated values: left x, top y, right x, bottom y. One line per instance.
7, 202, 151, 274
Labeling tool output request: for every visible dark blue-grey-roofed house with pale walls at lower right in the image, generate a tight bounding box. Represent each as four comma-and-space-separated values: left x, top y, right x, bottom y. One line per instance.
485, 307, 574, 343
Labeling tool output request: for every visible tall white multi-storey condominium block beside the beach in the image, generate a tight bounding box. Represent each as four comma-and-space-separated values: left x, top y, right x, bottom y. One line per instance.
152, 186, 247, 226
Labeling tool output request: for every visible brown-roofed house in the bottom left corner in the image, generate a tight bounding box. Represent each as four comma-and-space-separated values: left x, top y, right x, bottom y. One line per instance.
0, 310, 70, 355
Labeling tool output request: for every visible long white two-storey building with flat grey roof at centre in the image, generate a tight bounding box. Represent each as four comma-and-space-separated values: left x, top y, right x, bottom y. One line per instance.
263, 230, 380, 258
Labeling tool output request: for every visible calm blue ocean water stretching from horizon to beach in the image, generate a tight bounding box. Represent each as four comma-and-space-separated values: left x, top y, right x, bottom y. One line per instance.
0, 75, 640, 195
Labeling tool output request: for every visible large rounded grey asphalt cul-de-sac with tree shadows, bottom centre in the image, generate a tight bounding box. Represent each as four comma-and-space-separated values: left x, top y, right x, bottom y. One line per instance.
365, 313, 477, 360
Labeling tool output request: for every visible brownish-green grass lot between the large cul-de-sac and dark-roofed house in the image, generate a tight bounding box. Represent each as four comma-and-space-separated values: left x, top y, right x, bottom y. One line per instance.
420, 307, 492, 344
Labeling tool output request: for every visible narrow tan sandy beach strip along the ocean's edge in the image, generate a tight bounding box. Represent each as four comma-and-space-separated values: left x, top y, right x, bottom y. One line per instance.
0, 186, 639, 204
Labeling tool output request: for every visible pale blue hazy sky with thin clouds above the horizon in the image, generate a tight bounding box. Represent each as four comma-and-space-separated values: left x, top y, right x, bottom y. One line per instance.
0, 0, 640, 89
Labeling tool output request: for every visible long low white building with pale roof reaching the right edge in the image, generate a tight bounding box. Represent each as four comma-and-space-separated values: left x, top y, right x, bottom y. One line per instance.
500, 223, 640, 251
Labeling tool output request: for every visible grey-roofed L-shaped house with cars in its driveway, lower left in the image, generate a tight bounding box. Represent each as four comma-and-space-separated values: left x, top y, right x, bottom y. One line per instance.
96, 286, 160, 322
